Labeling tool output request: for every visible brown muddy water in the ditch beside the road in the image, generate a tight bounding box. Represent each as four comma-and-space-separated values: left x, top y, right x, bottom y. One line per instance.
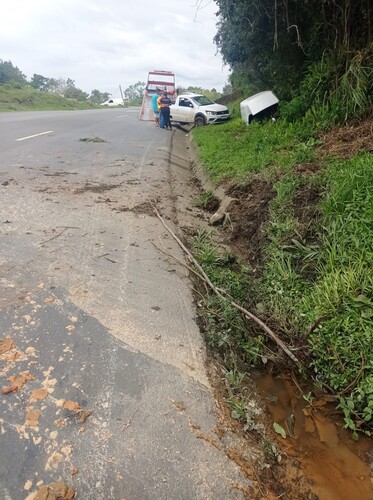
256, 374, 373, 500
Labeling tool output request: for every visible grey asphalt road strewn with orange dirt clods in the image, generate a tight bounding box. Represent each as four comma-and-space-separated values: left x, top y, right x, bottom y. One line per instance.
0, 109, 247, 500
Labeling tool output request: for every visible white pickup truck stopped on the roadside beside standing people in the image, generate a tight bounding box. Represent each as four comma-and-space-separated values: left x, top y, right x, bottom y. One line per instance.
171, 94, 229, 127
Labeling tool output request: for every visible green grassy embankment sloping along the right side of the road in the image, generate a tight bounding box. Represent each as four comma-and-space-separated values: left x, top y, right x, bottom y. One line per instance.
193, 105, 373, 436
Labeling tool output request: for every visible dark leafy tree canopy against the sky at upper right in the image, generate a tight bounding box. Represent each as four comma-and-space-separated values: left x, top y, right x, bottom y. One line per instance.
214, 0, 373, 98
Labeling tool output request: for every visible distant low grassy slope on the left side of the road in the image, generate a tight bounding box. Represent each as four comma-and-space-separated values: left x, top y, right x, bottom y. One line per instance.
0, 84, 97, 111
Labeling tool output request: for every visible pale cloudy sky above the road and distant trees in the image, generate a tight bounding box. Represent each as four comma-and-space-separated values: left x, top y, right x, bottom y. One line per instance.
0, 0, 229, 97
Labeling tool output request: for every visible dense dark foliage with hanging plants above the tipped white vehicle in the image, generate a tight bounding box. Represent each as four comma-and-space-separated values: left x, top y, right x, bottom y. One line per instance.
215, 0, 373, 120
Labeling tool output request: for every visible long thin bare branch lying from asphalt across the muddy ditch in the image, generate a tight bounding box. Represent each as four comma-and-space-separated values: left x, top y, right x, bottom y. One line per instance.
152, 205, 299, 365
